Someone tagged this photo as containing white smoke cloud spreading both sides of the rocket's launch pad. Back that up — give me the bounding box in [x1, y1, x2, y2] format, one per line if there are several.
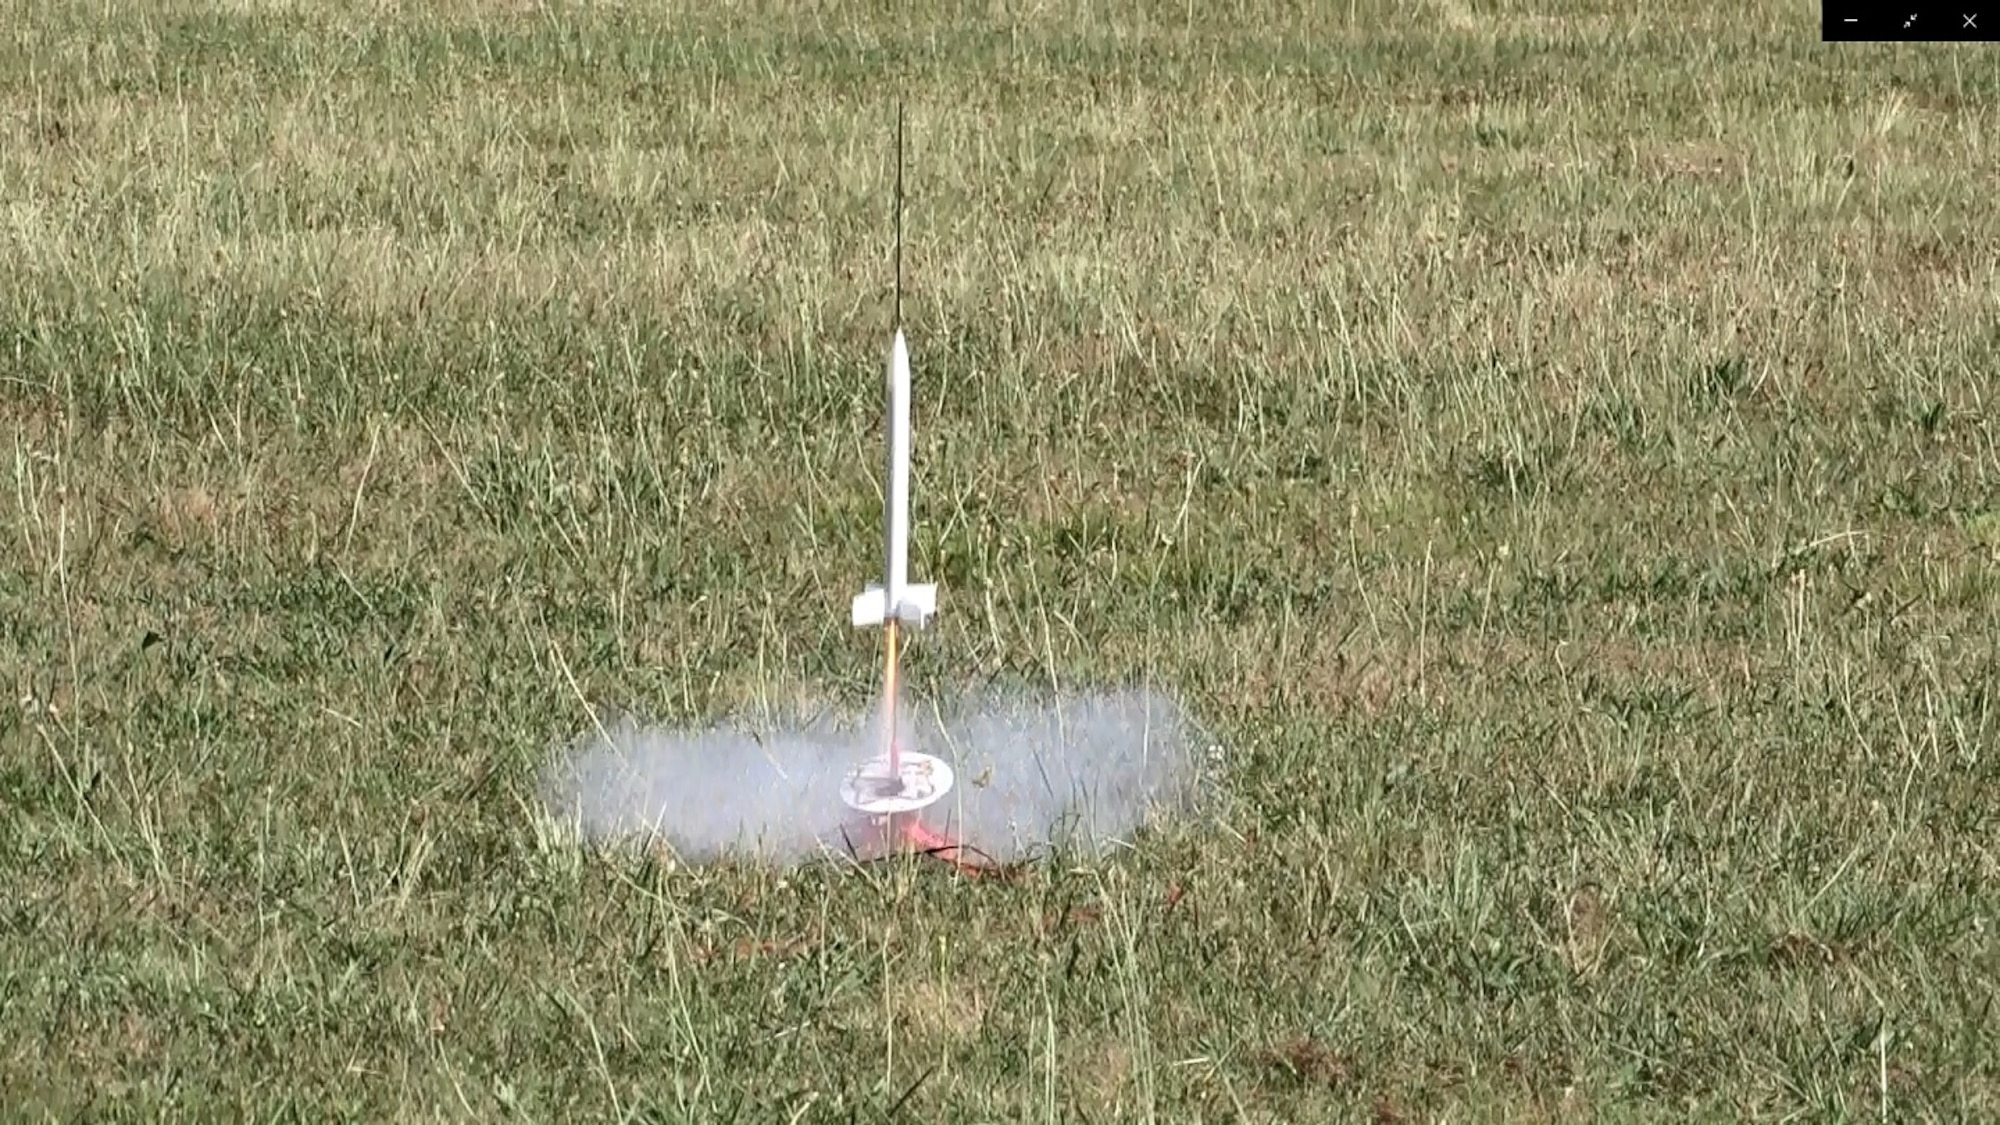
[544, 689, 1216, 863]
